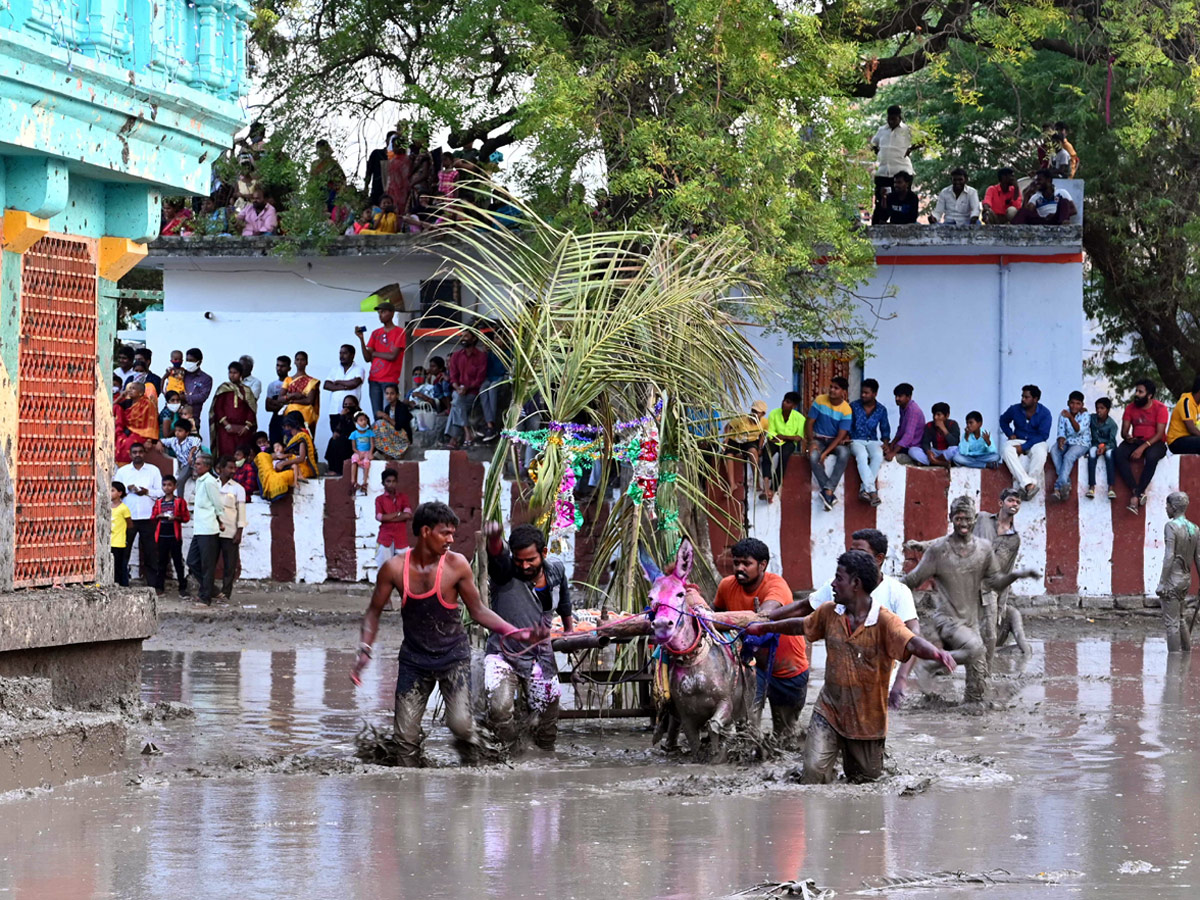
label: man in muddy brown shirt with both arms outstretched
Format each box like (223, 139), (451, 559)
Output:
(748, 550), (955, 785)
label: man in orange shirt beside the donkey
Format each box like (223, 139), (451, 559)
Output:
(713, 538), (809, 738)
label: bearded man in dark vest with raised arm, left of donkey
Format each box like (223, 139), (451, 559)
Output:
(484, 522), (574, 750)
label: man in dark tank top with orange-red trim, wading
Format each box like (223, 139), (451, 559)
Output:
(350, 503), (548, 767)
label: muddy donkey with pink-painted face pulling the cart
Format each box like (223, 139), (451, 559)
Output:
(641, 541), (755, 761)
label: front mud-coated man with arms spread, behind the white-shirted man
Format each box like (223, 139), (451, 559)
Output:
(902, 496), (1039, 703)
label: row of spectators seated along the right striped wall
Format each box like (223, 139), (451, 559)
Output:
(724, 376), (1200, 515)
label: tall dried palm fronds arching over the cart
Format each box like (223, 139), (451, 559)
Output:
(436, 190), (763, 608)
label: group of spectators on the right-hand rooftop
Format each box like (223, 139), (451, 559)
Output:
(871, 106), (1079, 226)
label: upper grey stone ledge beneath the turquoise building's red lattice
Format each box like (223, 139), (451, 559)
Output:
(0, 584), (158, 653)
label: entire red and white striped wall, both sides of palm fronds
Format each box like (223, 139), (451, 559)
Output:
(164, 451), (1200, 596)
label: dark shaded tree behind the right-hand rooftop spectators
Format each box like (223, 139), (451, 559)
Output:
(871, 42), (1200, 395)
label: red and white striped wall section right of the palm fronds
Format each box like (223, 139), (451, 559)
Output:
(710, 455), (1200, 596)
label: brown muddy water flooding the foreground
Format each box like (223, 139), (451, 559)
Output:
(0, 637), (1200, 900)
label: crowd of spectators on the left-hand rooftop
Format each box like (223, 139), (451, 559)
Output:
(160, 122), (504, 238)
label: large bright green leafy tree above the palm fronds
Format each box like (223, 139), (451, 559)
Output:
(250, 0), (872, 334)
